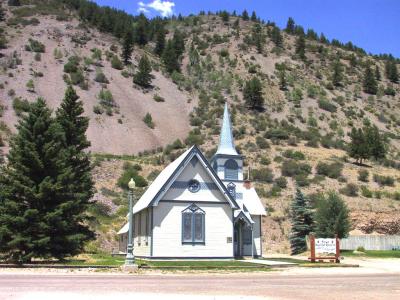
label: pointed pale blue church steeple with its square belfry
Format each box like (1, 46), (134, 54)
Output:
(211, 103), (243, 182)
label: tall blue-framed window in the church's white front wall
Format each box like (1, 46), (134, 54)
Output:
(182, 204), (205, 244)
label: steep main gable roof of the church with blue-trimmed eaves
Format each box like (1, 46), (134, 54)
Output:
(132, 146), (239, 214)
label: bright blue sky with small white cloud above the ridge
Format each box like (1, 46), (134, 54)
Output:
(95, 0), (400, 57)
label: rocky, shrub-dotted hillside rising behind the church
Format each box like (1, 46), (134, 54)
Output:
(0, 1), (400, 252)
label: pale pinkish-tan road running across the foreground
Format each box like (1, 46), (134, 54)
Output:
(0, 273), (400, 300)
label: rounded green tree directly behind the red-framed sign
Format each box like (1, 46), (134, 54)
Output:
(315, 192), (350, 239)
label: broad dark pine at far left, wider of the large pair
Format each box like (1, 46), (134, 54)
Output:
(0, 98), (63, 262)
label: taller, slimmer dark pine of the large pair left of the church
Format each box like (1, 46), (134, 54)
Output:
(50, 86), (94, 258)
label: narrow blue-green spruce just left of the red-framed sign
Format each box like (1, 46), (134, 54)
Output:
(289, 188), (314, 255)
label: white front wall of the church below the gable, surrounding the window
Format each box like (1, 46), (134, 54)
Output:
(152, 201), (233, 258)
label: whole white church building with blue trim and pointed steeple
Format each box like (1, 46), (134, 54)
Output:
(118, 104), (266, 259)
